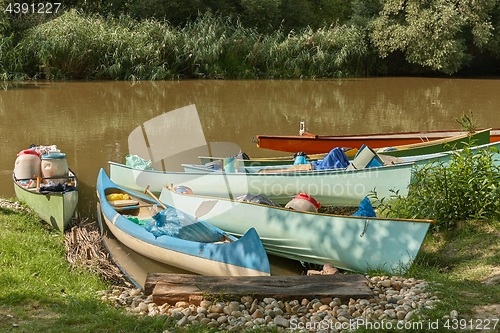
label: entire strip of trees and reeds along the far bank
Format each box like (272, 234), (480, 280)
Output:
(0, 0), (500, 80)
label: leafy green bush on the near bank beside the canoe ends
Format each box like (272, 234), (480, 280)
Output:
(381, 147), (500, 229)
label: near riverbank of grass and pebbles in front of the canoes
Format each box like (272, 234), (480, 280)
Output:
(0, 200), (500, 332)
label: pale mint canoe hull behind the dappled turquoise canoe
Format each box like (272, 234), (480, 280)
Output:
(109, 162), (413, 206)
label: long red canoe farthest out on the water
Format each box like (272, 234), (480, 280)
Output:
(254, 124), (500, 154)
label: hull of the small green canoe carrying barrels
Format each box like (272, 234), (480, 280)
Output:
(13, 171), (78, 232)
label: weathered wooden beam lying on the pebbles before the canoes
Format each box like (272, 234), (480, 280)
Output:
(144, 273), (373, 305)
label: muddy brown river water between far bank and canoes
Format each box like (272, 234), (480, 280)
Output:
(0, 78), (500, 282)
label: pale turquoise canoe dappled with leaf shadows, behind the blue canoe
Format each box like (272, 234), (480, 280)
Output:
(159, 188), (433, 274)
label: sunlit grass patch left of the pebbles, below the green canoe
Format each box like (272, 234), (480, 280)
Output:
(0, 208), (174, 333)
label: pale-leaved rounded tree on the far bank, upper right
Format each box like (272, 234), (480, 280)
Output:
(370, 0), (498, 74)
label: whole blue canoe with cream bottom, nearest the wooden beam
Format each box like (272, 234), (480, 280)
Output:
(96, 169), (270, 276)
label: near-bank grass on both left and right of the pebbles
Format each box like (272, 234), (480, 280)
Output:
(0, 201), (500, 333)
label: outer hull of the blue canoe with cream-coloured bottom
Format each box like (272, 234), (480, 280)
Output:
(96, 169), (270, 276)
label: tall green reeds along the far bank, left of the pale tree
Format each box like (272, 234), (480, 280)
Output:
(0, 10), (367, 80)
